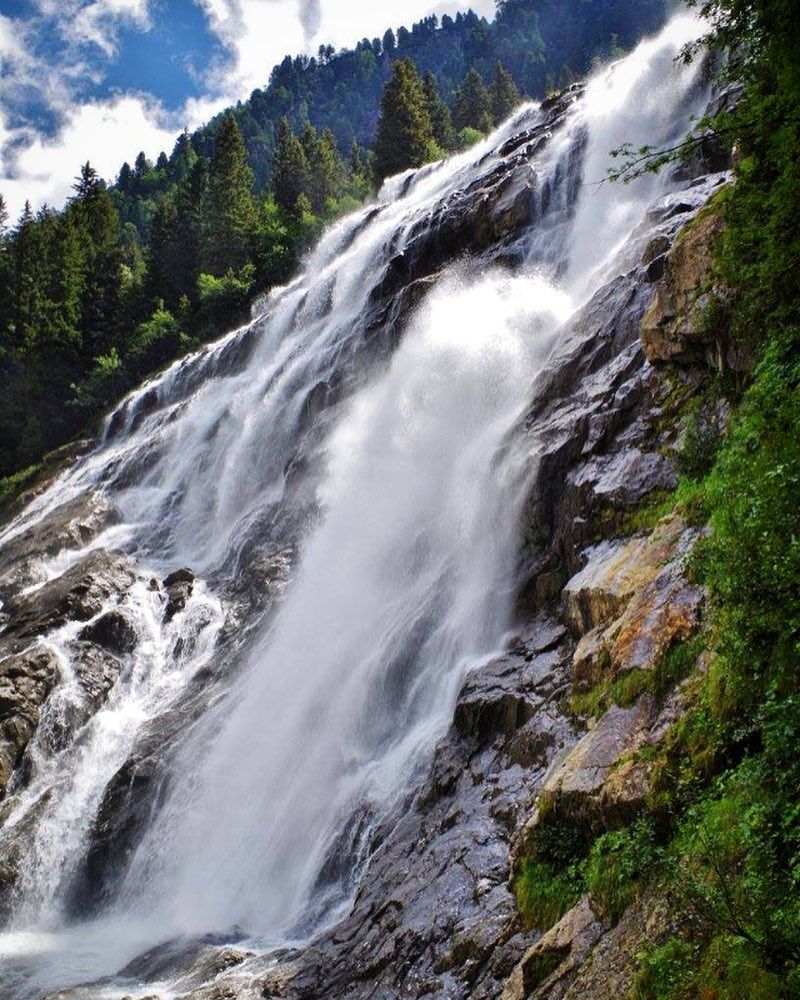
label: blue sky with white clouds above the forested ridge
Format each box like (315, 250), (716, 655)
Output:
(0, 0), (494, 220)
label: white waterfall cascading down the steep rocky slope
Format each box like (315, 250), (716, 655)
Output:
(0, 18), (704, 996)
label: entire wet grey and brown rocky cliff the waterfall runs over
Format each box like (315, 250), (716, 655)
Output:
(0, 37), (746, 1000)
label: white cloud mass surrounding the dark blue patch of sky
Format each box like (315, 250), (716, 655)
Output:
(0, 0), (494, 217)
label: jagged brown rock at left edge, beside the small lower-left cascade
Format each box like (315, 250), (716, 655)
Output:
(0, 645), (59, 799)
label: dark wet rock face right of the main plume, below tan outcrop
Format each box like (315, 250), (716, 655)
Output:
(520, 176), (723, 613)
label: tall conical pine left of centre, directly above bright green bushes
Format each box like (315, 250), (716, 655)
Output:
(201, 114), (257, 277)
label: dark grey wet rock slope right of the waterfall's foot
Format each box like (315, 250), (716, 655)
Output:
(236, 619), (574, 1000)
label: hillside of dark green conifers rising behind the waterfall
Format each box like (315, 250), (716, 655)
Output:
(0, 0), (665, 490)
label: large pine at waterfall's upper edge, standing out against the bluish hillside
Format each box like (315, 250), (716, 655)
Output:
(375, 59), (434, 180)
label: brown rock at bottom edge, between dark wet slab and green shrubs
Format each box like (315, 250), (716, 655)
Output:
(500, 896), (605, 1000)
